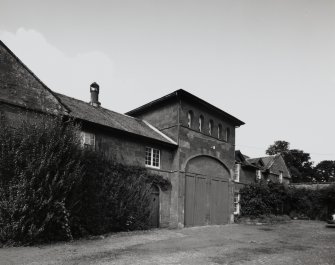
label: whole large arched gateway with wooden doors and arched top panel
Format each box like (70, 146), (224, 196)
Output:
(184, 156), (230, 226)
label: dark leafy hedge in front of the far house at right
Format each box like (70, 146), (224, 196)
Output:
(240, 182), (335, 220)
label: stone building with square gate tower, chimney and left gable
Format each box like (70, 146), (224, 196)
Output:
(0, 41), (244, 228)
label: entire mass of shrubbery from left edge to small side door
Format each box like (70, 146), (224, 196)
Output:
(0, 112), (171, 245)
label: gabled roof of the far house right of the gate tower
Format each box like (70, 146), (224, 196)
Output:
(246, 154), (291, 178)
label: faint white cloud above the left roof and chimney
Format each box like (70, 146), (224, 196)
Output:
(0, 28), (114, 104)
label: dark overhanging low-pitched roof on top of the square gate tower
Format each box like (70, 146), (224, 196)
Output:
(126, 89), (245, 126)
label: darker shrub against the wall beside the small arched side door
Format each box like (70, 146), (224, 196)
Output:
(73, 151), (170, 236)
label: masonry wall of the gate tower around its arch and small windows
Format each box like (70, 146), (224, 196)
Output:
(127, 98), (240, 227)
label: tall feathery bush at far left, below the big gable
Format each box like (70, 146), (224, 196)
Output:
(0, 116), (83, 244)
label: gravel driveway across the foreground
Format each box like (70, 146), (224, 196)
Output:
(0, 221), (335, 265)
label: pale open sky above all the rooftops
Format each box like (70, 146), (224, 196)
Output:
(0, 0), (335, 163)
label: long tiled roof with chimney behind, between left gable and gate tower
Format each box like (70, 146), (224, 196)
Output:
(56, 93), (177, 145)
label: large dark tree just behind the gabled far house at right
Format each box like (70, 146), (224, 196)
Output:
(266, 140), (313, 182)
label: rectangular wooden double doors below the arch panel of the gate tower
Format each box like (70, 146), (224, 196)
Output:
(184, 174), (229, 226)
